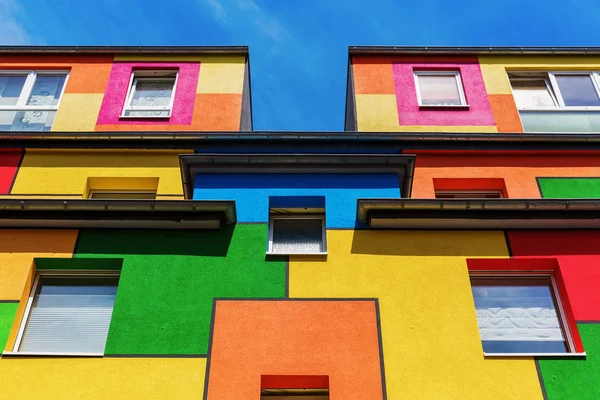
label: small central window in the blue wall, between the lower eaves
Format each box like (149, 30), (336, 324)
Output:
(268, 215), (327, 254)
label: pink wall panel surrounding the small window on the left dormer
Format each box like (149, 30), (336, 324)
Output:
(96, 62), (200, 125)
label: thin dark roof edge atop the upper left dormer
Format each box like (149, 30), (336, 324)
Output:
(0, 46), (248, 55)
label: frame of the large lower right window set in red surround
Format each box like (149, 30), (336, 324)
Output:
(469, 270), (585, 357)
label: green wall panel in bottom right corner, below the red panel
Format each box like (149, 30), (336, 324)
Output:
(539, 324), (600, 400)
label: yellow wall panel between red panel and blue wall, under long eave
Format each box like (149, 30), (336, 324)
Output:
(11, 150), (187, 196)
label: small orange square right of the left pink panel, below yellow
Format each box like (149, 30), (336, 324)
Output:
(192, 93), (242, 131)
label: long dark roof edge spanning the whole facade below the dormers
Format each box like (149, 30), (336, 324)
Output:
(5, 131), (600, 150)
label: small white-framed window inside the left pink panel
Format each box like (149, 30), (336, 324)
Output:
(121, 70), (177, 118)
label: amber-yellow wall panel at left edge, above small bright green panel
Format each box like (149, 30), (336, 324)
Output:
(0, 229), (77, 300)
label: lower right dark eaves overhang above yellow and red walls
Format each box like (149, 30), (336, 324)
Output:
(357, 199), (600, 230)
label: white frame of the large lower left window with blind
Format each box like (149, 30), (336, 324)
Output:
(2, 270), (121, 357)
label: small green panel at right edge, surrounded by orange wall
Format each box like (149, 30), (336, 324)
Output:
(538, 178), (600, 199)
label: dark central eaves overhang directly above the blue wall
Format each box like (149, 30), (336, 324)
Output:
(179, 154), (415, 199)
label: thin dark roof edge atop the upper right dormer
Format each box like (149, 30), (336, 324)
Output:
(348, 46), (600, 56)
